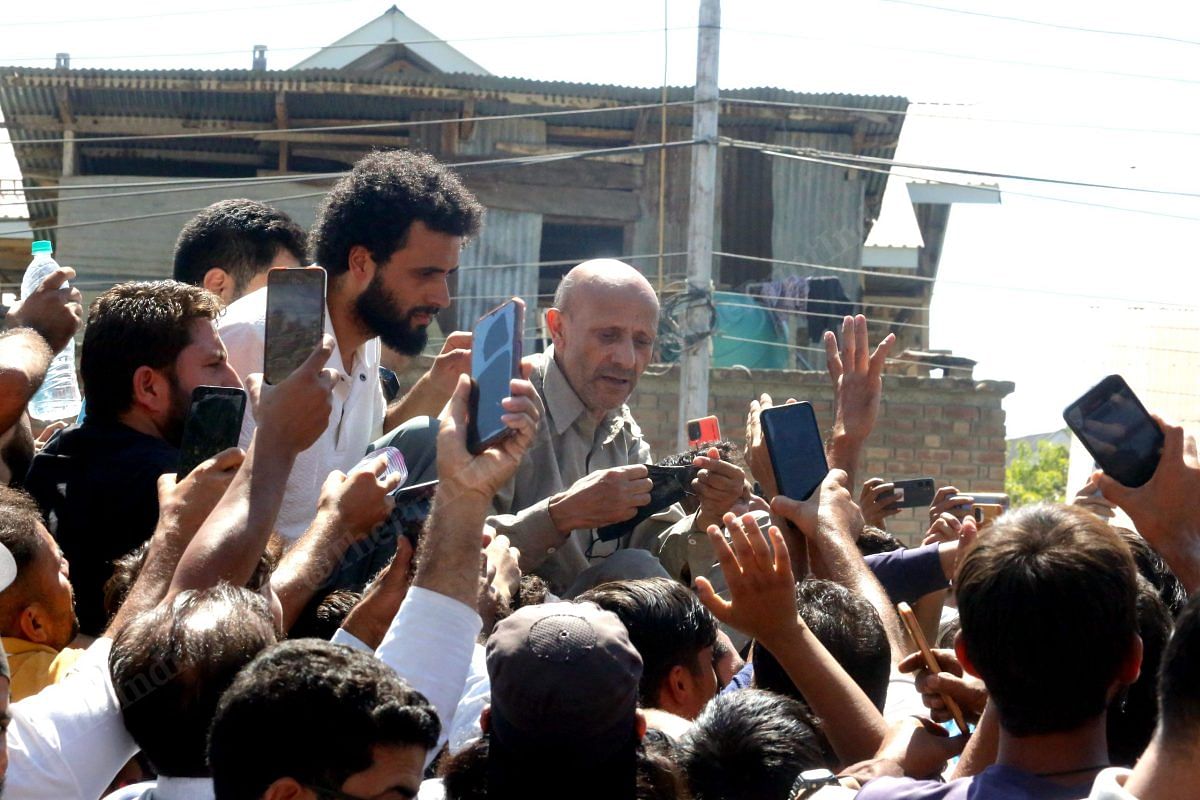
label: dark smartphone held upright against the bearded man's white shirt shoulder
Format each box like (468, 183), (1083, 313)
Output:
(263, 266), (325, 385)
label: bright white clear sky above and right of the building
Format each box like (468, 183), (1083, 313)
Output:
(0, 0), (1200, 435)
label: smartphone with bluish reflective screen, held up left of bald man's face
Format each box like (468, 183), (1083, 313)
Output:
(467, 297), (524, 455)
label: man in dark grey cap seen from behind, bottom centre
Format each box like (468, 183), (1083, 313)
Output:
(443, 603), (678, 800)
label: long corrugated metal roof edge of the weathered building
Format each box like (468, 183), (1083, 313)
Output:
(0, 67), (908, 239)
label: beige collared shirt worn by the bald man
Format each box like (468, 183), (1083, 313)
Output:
(487, 347), (661, 594)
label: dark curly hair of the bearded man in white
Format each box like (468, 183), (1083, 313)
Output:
(308, 150), (484, 278)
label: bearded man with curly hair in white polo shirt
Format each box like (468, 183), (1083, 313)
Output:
(221, 151), (484, 541)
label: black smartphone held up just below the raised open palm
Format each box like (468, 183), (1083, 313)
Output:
(760, 403), (829, 500)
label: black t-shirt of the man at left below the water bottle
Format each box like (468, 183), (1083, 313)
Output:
(25, 420), (179, 636)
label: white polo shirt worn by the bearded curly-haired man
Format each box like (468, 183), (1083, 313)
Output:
(220, 289), (388, 541)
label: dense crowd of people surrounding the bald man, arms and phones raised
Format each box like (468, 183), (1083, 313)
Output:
(0, 151), (1200, 800)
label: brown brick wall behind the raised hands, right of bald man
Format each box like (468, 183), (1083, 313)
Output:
(401, 359), (1013, 542)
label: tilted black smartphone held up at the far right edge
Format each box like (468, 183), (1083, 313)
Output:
(1062, 375), (1163, 486)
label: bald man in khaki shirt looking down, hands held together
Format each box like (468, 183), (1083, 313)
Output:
(488, 259), (744, 593)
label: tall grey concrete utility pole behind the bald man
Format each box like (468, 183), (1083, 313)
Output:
(676, 0), (721, 450)
